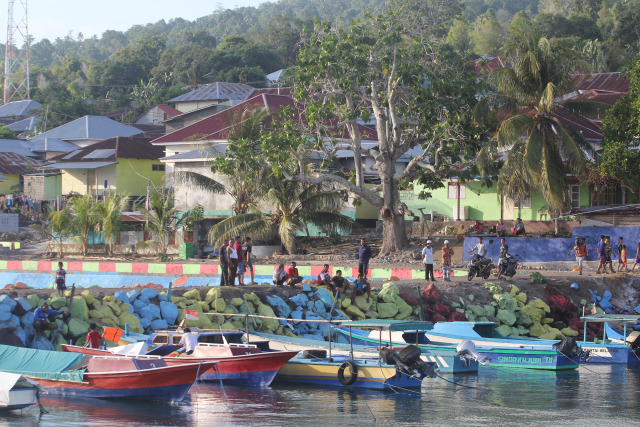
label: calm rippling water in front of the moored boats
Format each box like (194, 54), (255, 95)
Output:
(5, 366), (640, 427)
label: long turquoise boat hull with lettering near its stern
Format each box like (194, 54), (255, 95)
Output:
(337, 328), (579, 371)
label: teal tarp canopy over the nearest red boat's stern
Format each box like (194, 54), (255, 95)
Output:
(0, 345), (84, 381)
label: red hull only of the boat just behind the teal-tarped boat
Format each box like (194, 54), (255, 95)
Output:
(62, 345), (298, 387)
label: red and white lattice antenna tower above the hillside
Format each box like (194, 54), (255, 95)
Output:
(3, 0), (30, 104)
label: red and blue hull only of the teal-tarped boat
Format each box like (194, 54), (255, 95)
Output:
(26, 363), (215, 402)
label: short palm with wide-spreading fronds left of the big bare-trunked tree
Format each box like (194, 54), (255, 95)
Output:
(209, 175), (354, 254)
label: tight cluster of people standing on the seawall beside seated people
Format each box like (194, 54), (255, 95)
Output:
(218, 236), (257, 286)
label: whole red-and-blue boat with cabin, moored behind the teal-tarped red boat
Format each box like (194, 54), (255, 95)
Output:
(62, 343), (298, 387)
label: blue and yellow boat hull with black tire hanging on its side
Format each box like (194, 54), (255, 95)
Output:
(275, 357), (422, 390)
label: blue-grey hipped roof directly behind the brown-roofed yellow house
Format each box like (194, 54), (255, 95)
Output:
(32, 116), (142, 141)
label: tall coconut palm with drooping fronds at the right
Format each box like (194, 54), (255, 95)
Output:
(478, 33), (602, 217)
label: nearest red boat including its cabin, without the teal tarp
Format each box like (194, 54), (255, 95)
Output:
(24, 355), (216, 402)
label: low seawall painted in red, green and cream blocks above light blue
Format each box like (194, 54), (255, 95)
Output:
(0, 260), (466, 289)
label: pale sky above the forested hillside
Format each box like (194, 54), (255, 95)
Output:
(17, 0), (266, 43)
